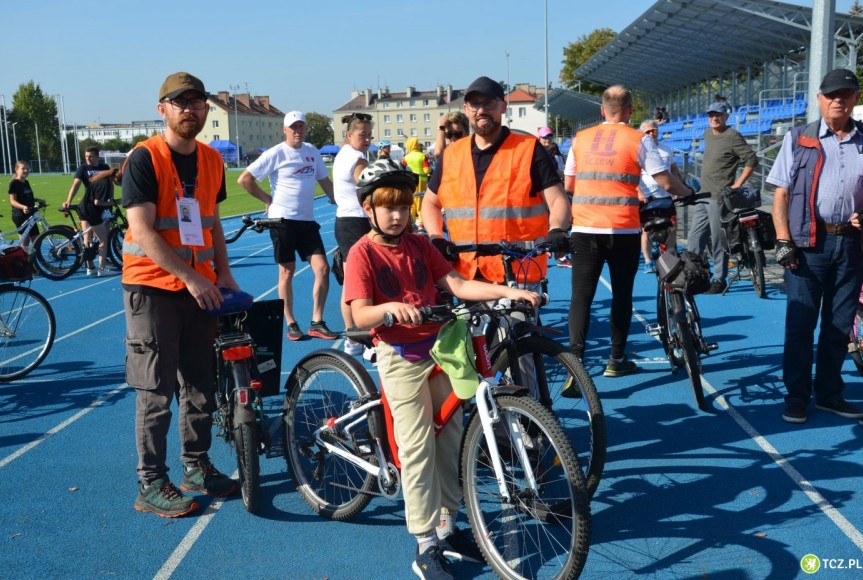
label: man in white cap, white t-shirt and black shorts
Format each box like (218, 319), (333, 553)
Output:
(243, 111), (338, 340)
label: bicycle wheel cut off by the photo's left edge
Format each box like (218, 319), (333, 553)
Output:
(0, 284), (56, 381)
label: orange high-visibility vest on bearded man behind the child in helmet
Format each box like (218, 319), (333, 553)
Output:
(437, 133), (548, 282)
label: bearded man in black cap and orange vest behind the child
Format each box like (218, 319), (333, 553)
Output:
(422, 77), (569, 283)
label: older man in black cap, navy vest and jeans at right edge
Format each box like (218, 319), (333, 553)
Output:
(767, 69), (863, 423)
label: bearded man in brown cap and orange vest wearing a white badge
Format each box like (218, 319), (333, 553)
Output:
(122, 72), (237, 518)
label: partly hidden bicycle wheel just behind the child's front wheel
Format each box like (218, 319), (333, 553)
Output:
(492, 336), (606, 496)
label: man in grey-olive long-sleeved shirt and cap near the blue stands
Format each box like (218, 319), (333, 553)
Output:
(686, 101), (758, 294)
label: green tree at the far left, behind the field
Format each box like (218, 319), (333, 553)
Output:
(9, 80), (60, 162)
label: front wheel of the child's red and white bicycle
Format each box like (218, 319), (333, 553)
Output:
(462, 396), (590, 578)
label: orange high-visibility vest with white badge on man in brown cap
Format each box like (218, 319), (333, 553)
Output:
(123, 135), (225, 291)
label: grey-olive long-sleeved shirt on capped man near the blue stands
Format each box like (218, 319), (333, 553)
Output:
(701, 127), (758, 199)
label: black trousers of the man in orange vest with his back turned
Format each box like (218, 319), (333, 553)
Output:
(569, 233), (641, 359)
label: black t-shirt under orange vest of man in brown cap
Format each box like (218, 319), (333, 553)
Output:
(122, 147), (228, 207)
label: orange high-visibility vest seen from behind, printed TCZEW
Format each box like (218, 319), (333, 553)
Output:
(572, 123), (644, 234)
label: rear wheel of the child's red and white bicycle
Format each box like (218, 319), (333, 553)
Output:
(284, 349), (376, 520)
